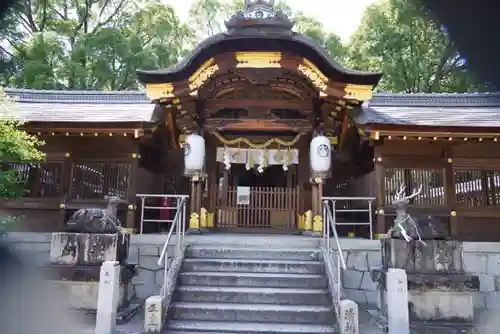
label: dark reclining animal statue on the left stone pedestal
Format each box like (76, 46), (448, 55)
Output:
(66, 198), (123, 233)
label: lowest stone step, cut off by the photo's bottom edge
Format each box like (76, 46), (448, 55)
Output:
(167, 320), (335, 334)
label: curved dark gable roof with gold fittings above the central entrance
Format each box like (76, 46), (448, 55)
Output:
(137, 0), (382, 100)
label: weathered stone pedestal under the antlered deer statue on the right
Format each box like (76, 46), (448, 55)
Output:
(373, 238), (479, 322)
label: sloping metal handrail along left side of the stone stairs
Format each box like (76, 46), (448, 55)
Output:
(158, 197), (187, 299)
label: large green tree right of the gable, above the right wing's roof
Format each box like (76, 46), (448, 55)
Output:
(349, 0), (485, 93)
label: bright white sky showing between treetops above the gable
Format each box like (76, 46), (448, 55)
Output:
(163, 0), (375, 42)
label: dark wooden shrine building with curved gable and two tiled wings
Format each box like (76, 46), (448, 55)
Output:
(0, 0), (500, 241)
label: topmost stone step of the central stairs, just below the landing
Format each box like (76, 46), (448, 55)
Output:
(185, 246), (322, 261)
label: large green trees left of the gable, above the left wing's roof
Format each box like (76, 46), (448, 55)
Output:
(0, 0), (190, 90)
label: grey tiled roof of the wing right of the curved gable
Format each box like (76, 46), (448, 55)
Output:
(353, 93), (500, 127)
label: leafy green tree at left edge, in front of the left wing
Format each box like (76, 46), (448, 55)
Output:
(0, 88), (45, 198)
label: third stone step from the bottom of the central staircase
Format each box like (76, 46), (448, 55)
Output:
(174, 285), (331, 305)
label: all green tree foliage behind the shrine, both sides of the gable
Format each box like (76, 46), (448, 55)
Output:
(0, 0), (486, 92)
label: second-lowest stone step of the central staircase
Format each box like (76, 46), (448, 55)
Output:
(169, 302), (335, 324)
